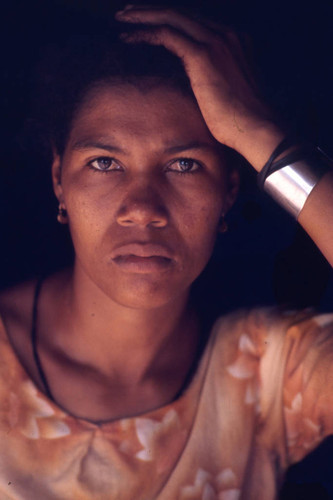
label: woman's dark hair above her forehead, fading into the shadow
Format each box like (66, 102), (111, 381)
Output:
(32, 29), (194, 158)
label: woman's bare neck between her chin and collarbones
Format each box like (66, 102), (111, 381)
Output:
(50, 267), (199, 384)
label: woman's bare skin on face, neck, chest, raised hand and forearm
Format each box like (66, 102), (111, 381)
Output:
(0, 6), (333, 422)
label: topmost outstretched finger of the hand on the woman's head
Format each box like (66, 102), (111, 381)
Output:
(116, 7), (214, 43)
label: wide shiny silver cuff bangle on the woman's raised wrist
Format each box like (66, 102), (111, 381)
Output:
(263, 149), (331, 220)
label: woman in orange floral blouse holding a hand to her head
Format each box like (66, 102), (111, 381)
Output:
(0, 7), (333, 500)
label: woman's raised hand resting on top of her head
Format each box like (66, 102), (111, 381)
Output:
(116, 6), (284, 171)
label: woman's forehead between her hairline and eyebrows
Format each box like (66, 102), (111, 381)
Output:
(69, 83), (218, 148)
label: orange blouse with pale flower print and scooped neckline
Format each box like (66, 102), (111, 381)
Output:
(0, 310), (333, 500)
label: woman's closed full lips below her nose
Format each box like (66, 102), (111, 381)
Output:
(111, 242), (174, 273)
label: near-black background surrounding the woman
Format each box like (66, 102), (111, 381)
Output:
(0, 0), (333, 499)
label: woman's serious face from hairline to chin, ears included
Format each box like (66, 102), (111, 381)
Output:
(53, 84), (235, 309)
